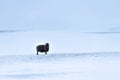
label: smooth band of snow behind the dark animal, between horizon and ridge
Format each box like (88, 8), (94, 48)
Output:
(0, 30), (120, 55)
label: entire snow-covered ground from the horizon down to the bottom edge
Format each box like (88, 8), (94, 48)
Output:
(0, 30), (120, 80)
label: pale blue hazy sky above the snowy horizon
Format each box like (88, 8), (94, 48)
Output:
(0, 0), (120, 31)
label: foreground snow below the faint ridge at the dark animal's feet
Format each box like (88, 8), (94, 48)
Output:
(0, 52), (120, 80)
